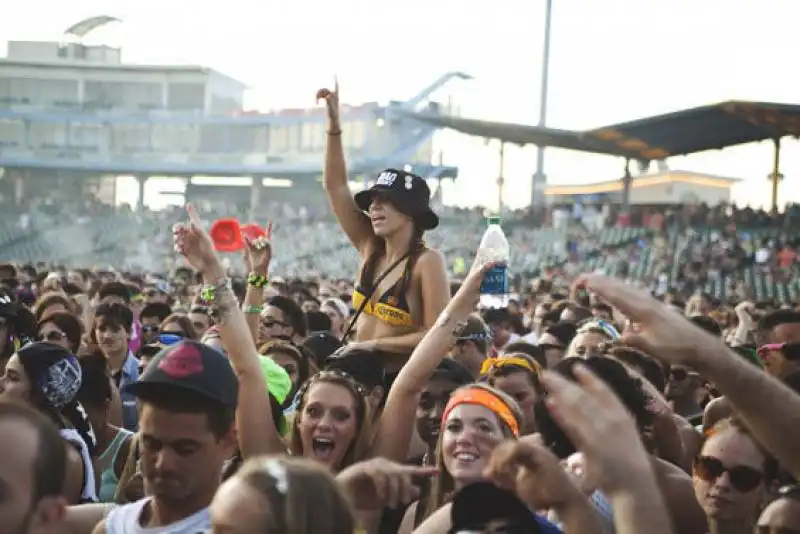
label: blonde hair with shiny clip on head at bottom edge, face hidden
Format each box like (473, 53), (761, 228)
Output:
(234, 456), (356, 534)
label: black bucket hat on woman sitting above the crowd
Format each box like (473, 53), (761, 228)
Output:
(355, 169), (439, 230)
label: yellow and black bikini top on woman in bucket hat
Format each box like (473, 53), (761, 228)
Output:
(352, 254), (414, 326)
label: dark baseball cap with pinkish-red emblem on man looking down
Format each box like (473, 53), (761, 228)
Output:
(123, 340), (239, 409)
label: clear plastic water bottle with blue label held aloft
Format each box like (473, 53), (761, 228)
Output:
(477, 217), (511, 308)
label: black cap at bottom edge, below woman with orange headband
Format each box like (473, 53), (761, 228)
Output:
(450, 482), (542, 534)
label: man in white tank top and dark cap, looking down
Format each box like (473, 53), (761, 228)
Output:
(94, 341), (238, 534)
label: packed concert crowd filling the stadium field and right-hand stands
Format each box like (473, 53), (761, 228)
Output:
(0, 84), (800, 534)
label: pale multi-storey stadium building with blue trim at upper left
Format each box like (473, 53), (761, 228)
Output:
(0, 34), (464, 210)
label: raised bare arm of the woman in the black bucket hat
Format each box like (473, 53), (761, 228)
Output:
(317, 81), (375, 256)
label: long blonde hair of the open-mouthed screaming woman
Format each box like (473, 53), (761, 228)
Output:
(289, 371), (373, 470)
